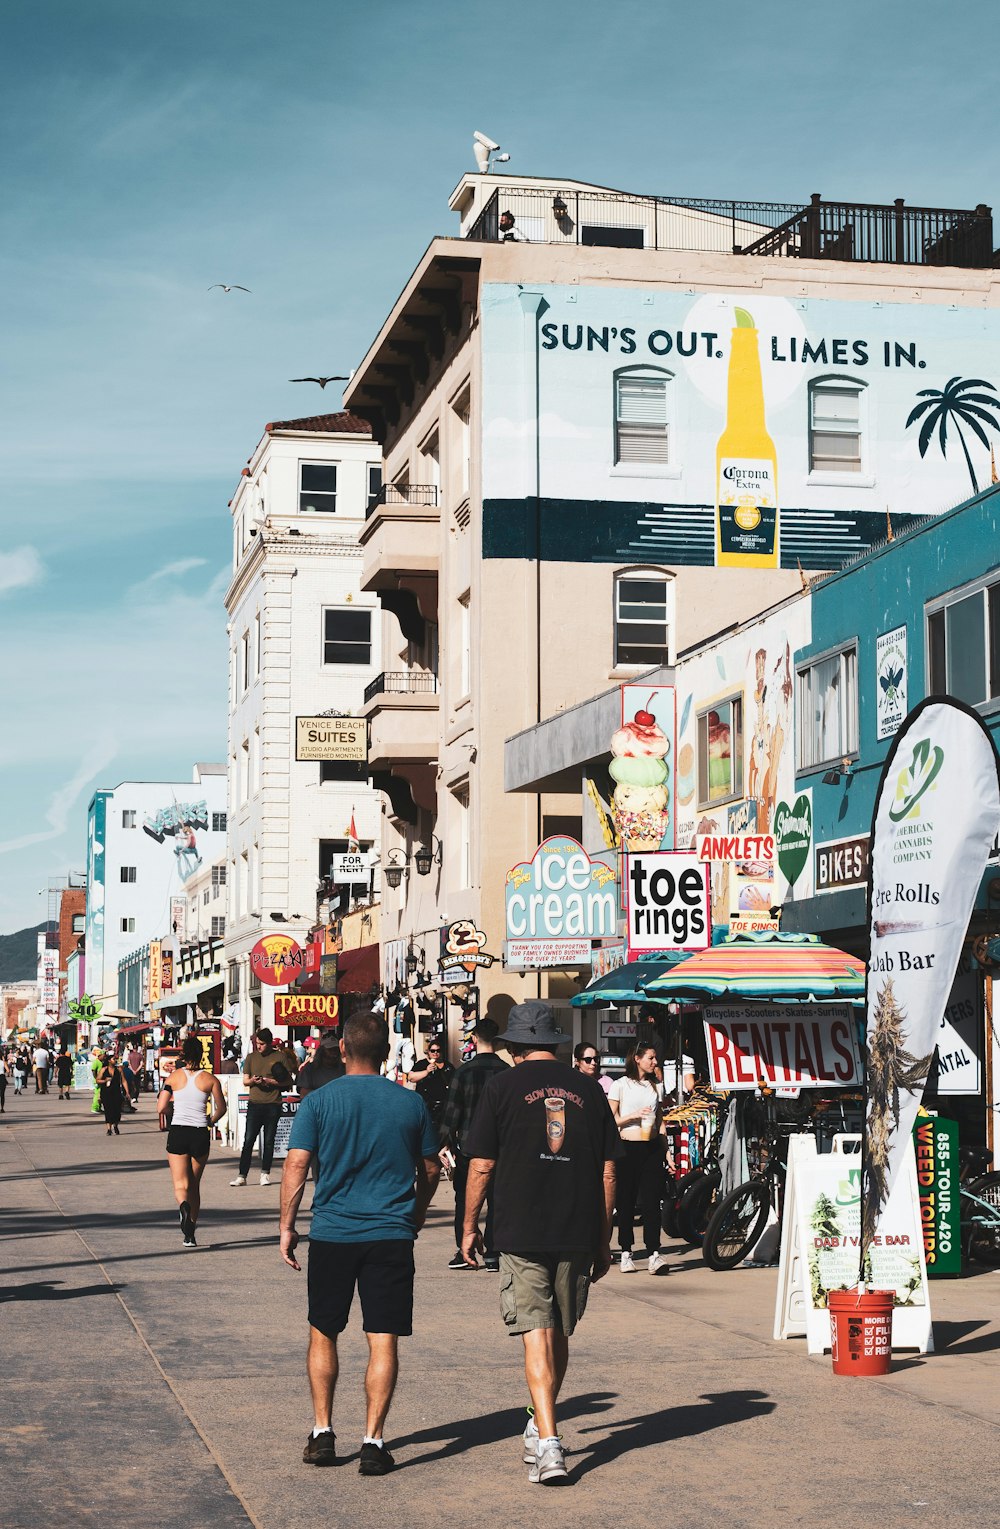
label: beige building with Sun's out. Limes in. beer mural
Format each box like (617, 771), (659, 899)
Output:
(344, 174), (1000, 1051)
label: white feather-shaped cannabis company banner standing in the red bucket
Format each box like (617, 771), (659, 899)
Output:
(861, 696), (1000, 1255)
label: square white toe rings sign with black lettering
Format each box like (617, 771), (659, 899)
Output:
(625, 850), (713, 956)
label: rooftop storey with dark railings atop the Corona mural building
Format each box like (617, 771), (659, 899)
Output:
(466, 185), (1000, 269)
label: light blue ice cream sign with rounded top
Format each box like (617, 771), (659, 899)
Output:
(505, 836), (618, 968)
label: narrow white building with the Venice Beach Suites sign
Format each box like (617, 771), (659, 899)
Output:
(225, 413), (385, 1034)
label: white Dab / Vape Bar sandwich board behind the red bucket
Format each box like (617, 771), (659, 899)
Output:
(774, 1136), (934, 1353)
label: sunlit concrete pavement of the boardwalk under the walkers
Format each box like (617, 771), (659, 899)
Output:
(0, 1090), (1000, 1529)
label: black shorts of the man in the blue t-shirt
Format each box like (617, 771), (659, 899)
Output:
(309, 1238), (413, 1338)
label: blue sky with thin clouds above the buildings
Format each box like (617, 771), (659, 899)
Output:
(0, 0), (1000, 933)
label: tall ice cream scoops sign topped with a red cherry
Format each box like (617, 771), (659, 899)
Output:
(609, 685), (674, 852)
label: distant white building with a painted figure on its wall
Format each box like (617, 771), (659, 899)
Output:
(86, 765), (226, 1008)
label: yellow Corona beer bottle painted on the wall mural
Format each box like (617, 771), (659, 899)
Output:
(716, 307), (778, 569)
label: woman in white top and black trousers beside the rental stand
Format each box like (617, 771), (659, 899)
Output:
(609, 1044), (668, 1275)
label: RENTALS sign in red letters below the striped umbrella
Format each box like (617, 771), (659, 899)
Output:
(705, 1003), (861, 1089)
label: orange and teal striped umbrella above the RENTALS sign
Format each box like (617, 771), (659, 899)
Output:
(645, 934), (865, 1003)
